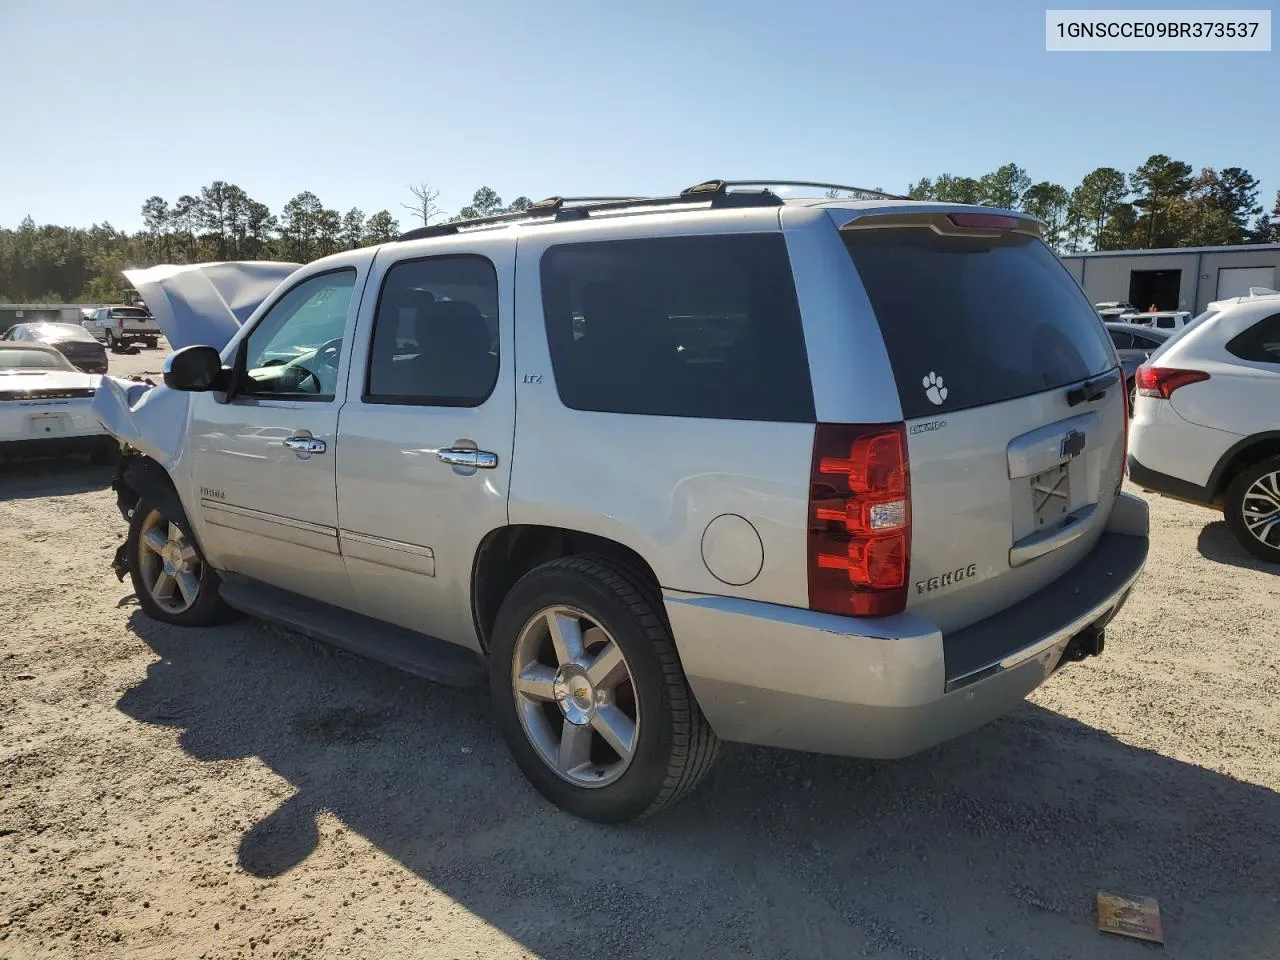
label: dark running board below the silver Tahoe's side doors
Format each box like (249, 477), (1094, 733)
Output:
(221, 575), (485, 686)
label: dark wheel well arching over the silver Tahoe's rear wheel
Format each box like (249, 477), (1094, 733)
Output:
(471, 524), (658, 650)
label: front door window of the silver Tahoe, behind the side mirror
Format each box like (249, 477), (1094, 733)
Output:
(242, 270), (356, 401)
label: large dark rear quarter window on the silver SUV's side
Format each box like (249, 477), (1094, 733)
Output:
(541, 233), (814, 422)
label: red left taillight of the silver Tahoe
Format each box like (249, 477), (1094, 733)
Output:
(809, 424), (911, 617)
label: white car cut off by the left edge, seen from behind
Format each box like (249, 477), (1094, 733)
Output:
(0, 342), (119, 462)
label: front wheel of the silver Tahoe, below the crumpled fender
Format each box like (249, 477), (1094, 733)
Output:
(125, 497), (232, 627)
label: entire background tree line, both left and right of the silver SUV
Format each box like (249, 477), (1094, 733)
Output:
(0, 160), (1280, 303)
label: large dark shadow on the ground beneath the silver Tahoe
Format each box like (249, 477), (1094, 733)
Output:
(118, 612), (1280, 959)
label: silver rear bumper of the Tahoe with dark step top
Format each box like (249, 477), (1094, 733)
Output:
(663, 494), (1147, 758)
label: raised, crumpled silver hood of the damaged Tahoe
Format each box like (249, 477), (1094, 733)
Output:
(123, 260), (301, 351)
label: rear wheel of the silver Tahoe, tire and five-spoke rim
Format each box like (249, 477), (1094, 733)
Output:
(489, 557), (719, 823)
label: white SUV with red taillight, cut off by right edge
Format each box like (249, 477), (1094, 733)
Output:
(1129, 294), (1280, 563)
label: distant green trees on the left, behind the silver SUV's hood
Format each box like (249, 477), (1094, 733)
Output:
(0, 180), (530, 303)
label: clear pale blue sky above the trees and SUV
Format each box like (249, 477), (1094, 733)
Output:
(0, 0), (1280, 229)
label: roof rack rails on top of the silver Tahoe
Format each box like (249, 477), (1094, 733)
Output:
(397, 180), (906, 241)
